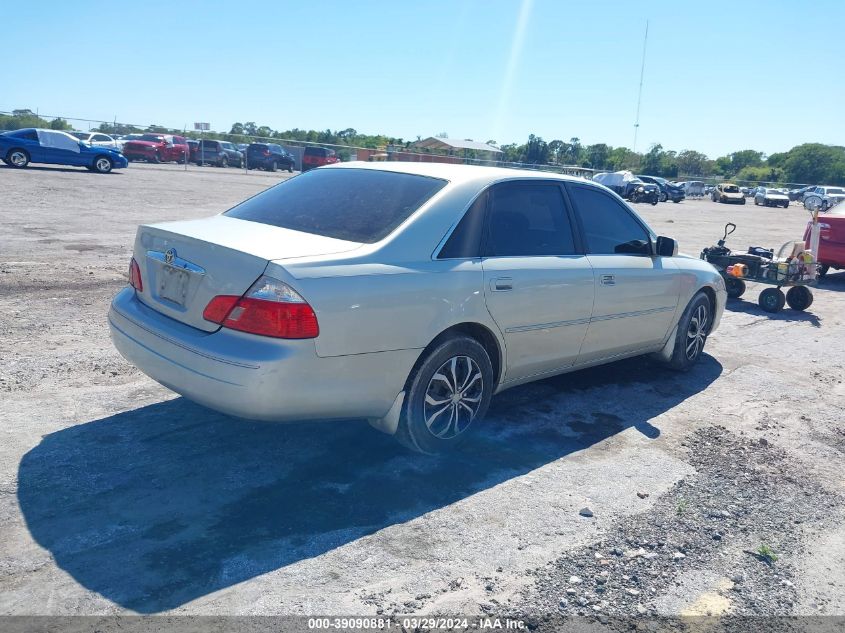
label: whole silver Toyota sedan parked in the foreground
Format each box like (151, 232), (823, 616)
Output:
(108, 162), (727, 453)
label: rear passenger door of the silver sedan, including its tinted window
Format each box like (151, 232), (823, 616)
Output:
(482, 180), (595, 382)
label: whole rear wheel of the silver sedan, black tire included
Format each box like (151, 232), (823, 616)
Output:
(396, 336), (494, 455)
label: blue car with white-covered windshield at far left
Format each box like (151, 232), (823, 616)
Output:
(0, 128), (129, 174)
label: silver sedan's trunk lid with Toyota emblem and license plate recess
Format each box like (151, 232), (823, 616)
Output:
(134, 215), (360, 332)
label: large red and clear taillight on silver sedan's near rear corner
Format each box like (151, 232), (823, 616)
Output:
(202, 275), (320, 338)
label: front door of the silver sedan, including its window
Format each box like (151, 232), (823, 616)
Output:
(567, 184), (681, 364)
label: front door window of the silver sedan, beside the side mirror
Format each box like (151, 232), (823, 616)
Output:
(570, 186), (651, 255)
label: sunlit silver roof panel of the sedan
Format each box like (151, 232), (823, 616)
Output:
(320, 161), (594, 184)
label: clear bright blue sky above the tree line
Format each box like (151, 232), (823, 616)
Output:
(0, 0), (845, 157)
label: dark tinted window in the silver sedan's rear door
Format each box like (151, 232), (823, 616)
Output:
(484, 183), (575, 257)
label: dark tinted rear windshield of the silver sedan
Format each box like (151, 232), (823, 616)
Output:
(225, 169), (446, 244)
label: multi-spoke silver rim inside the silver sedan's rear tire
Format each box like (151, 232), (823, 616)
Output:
(423, 356), (484, 439)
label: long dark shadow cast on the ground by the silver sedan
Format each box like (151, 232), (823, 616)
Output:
(18, 356), (722, 613)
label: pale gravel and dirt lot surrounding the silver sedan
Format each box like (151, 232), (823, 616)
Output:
(0, 164), (845, 630)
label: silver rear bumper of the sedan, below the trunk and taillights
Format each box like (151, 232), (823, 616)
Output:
(108, 288), (419, 421)
